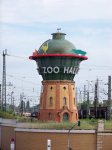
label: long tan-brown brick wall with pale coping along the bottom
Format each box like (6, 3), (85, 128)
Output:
(0, 125), (112, 150)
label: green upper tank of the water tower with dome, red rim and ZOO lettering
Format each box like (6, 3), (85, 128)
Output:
(30, 32), (87, 80)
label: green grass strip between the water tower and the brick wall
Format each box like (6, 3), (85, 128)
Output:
(16, 119), (97, 130)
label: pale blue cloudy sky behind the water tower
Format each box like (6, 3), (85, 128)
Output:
(0, 0), (112, 103)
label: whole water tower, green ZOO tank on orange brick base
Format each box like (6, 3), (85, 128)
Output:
(29, 31), (87, 122)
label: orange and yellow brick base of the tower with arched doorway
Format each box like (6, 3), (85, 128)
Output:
(39, 80), (78, 122)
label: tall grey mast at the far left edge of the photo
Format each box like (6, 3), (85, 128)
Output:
(2, 49), (7, 111)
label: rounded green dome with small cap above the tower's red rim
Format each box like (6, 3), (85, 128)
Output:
(38, 32), (76, 54)
